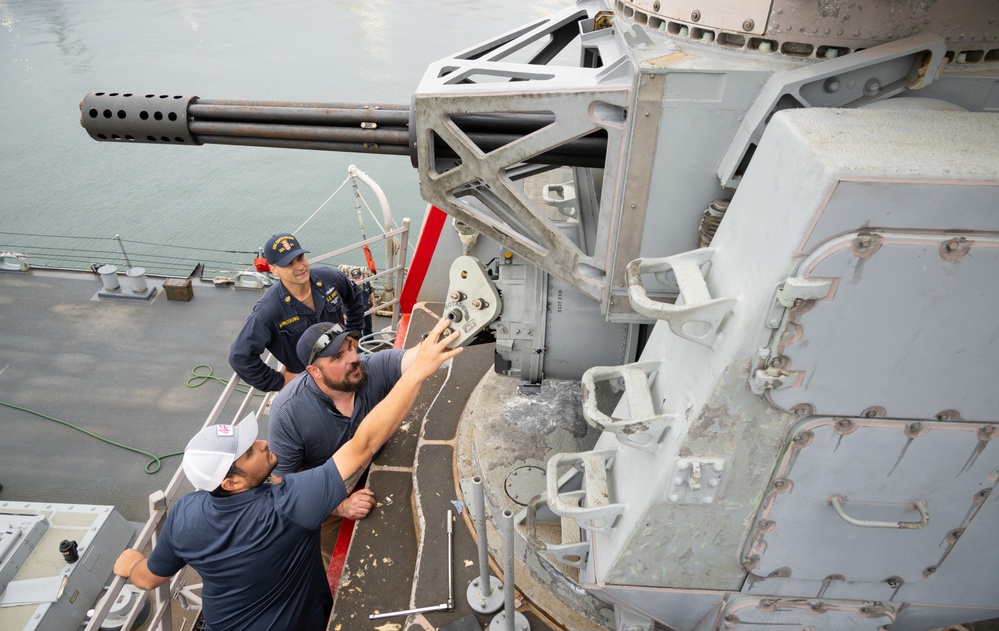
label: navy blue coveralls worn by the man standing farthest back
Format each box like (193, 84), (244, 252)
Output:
(229, 266), (365, 392)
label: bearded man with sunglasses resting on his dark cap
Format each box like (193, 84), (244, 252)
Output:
(268, 322), (416, 564)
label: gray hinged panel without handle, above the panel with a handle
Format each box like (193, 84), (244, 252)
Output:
(770, 235), (999, 420)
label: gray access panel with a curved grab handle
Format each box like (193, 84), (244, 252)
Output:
(750, 418), (997, 588)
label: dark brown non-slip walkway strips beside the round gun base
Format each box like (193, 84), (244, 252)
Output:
(329, 303), (572, 631)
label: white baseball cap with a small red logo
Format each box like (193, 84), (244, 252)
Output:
(184, 412), (257, 491)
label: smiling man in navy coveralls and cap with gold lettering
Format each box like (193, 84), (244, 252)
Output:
(229, 234), (366, 392)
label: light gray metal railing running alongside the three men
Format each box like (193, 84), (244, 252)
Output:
(85, 218), (410, 631)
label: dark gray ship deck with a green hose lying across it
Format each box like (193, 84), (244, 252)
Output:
(0, 269), (260, 522)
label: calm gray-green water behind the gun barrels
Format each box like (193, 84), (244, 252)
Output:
(0, 0), (568, 275)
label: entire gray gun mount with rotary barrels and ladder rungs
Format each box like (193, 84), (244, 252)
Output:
(82, 0), (999, 631)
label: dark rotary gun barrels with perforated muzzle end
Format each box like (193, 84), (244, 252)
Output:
(80, 92), (607, 167)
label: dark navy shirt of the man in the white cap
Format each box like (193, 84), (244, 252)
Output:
(148, 460), (347, 631)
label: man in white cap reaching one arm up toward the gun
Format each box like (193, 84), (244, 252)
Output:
(114, 319), (461, 631)
